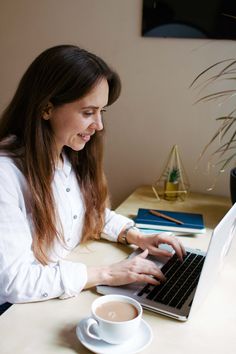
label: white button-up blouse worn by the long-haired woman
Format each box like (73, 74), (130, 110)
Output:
(0, 156), (132, 305)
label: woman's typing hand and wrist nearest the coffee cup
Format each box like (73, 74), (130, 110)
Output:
(85, 250), (165, 289)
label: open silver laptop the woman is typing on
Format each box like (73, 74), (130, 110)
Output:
(97, 203), (236, 321)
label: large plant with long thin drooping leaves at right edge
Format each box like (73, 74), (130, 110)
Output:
(191, 59), (236, 203)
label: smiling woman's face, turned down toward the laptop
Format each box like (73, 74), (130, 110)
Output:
(49, 79), (109, 158)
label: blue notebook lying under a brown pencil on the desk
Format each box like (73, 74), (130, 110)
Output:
(134, 208), (206, 233)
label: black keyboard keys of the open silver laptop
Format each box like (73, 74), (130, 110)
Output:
(138, 252), (205, 309)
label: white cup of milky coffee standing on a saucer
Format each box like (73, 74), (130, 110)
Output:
(84, 295), (142, 344)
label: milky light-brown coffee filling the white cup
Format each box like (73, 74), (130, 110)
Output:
(95, 301), (138, 322)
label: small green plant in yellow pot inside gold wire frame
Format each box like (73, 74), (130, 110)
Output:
(164, 166), (180, 200)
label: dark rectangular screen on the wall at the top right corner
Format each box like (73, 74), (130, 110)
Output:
(142, 0), (236, 39)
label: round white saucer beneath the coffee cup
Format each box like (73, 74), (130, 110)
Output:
(76, 319), (153, 354)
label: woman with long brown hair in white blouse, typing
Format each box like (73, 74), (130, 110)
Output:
(0, 45), (185, 304)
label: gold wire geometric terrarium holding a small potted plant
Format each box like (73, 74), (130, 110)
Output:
(152, 145), (190, 201)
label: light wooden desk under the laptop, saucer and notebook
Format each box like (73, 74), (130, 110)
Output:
(0, 186), (236, 354)
